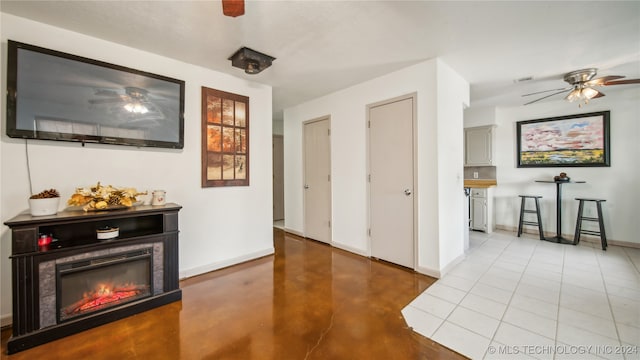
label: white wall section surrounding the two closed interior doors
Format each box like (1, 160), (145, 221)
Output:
(284, 59), (469, 276)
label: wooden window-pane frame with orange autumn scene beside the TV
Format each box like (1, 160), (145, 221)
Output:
(202, 86), (249, 187)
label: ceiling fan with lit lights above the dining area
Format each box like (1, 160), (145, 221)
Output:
(522, 68), (640, 107)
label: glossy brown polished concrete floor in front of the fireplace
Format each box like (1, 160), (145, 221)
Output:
(2, 229), (464, 360)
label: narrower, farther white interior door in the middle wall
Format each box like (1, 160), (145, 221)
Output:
(304, 118), (331, 243)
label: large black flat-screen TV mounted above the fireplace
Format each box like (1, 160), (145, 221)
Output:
(7, 40), (185, 149)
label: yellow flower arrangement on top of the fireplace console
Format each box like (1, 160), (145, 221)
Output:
(67, 182), (147, 211)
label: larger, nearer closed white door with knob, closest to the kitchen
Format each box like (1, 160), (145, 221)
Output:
(369, 98), (415, 269)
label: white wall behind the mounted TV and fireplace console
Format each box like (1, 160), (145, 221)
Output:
(0, 14), (273, 319)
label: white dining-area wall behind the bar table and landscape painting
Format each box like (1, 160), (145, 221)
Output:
(488, 86), (640, 245)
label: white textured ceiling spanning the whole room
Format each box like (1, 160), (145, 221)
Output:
(0, 0), (640, 118)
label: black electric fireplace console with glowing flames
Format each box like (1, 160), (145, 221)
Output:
(5, 204), (182, 354)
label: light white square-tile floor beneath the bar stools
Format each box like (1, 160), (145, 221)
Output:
(402, 231), (640, 360)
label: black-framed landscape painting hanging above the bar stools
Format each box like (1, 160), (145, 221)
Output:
(516, 111), (611, 168)
